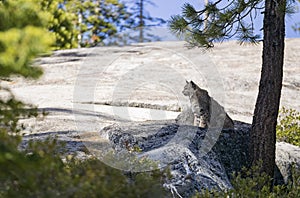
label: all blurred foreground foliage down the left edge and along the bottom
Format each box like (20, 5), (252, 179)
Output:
(0, 0), (164, 198)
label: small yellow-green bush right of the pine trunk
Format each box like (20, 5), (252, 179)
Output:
(276, 107), (300, 146)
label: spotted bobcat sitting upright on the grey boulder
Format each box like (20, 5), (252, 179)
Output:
(182, 81), (234, 128)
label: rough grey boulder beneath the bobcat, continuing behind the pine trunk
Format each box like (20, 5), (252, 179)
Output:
(101, 121), (300, 197)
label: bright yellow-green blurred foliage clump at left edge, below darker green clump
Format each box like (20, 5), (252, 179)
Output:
(0, 26), (51, 78)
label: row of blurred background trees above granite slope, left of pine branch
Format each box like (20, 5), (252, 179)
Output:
(30, 0), (165, 49)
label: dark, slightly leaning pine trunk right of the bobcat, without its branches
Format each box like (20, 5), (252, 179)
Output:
(251, 0), (286, 178)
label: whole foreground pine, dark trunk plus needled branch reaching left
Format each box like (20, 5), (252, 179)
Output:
(169, 0), (289, 184)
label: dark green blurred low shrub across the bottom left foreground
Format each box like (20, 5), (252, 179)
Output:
(0, 132), (165, 198)
